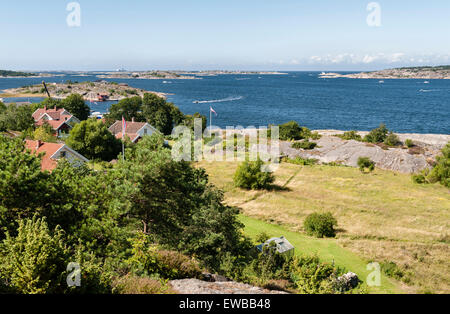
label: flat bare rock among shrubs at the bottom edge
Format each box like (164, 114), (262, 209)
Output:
(169, 279), (287, 294)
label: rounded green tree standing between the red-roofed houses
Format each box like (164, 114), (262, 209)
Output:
(66, 119), (122, 161)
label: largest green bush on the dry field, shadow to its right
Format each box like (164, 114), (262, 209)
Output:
(234, 159), (275, 190)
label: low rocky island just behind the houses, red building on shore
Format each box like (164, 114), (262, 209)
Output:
(0, 81), (166, 101)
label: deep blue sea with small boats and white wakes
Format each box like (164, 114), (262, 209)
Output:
(0, 72), (450, 134)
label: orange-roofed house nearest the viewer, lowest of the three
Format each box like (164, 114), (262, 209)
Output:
(25, 140), (89, 171)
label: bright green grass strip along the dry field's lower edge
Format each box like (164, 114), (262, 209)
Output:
(240, 215), (400, 293)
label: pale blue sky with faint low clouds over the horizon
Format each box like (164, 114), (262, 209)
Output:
(0, 0), (450, 71)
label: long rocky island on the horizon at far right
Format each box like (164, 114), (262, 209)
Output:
(319, 65), (450, 80)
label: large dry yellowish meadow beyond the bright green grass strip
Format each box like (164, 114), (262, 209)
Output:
(199, 161), (450, 293)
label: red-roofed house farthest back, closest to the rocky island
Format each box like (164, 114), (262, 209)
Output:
(33, 106), (80, 136)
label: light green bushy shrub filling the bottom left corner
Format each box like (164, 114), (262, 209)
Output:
(0, 218), (69, 294)
